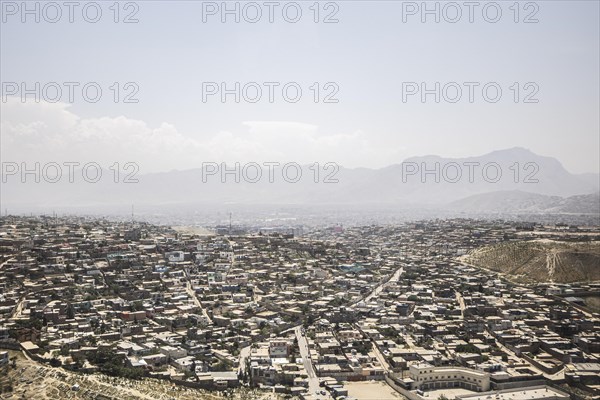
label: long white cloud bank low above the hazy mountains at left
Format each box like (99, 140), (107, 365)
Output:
(0, 99), (404, 173)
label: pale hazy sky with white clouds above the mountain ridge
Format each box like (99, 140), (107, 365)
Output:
(0, 1), (600, 173)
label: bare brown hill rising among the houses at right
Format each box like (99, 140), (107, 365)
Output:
(464, 240), (600, 283)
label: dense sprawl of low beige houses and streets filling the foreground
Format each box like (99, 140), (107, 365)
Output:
(0, 216), (600, 400)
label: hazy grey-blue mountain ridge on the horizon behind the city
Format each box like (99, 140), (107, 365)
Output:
(1, 148), (600, 213)
